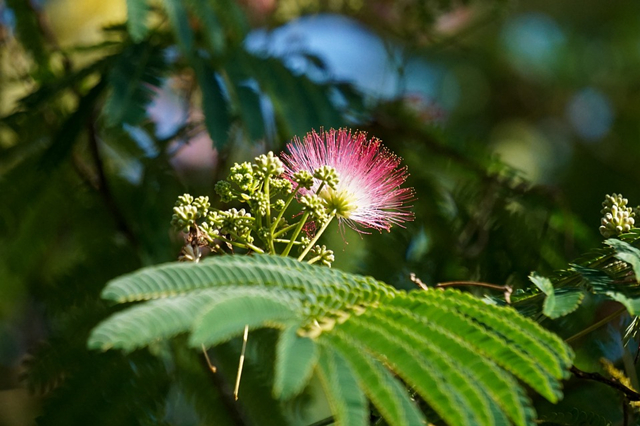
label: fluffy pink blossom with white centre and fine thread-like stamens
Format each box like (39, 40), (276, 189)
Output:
(282, 129), (414, 232)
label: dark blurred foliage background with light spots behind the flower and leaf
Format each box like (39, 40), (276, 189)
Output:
(0, 0), (640, 426)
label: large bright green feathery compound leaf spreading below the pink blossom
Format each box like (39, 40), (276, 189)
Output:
(89, 255), (573, 426)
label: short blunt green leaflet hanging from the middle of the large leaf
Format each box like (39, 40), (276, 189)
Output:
(273, 325), (318, 399)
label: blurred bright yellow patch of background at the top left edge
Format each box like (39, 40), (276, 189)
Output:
(45, 0), (127, 48)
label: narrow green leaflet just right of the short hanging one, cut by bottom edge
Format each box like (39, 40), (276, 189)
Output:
(319, 347), (369, 426)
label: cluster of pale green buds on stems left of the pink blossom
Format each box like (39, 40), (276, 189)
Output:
(171, 152), (339, 266)
